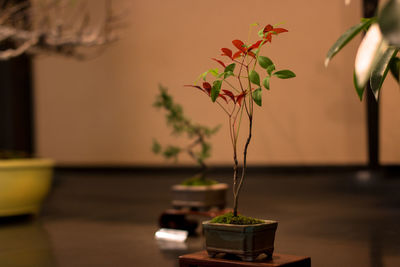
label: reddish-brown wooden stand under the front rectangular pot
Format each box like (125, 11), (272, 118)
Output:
(179, 250), (311, 267)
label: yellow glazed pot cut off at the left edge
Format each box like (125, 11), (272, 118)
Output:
(0, 159), (54, 216)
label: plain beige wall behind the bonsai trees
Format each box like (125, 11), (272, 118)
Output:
(35, 0), (400, 165)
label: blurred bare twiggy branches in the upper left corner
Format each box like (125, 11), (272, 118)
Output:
(0, 0), (122, 60)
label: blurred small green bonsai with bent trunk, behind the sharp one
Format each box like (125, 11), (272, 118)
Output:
(153, 85), (220, 185)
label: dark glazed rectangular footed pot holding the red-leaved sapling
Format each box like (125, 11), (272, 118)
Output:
(203, 220), (278, 261)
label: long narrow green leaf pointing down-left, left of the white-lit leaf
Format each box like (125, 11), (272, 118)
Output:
(325, 18), (376, 67)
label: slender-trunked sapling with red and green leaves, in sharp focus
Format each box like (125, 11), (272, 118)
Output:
(187, 24), (296, 220)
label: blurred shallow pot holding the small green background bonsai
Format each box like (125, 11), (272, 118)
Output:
(172, 183), (228, 210)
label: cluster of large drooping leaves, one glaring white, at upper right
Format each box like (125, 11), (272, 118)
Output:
(325, 0), (400, 101)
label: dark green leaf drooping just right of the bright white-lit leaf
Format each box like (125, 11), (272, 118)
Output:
(369, 47), (397, 101)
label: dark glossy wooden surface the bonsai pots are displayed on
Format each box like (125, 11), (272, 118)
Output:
(0, 170), (400, 267)
